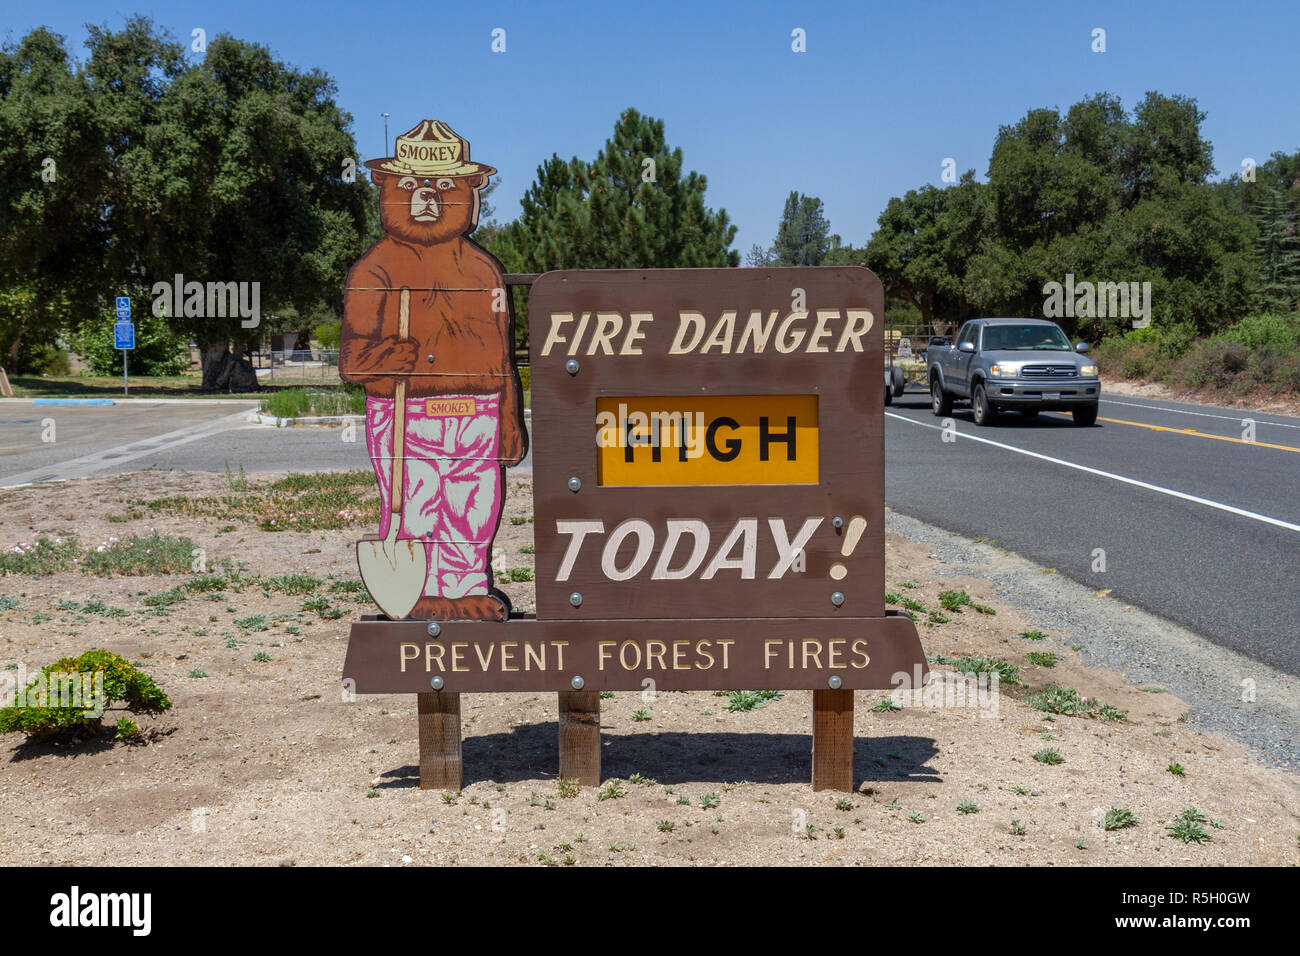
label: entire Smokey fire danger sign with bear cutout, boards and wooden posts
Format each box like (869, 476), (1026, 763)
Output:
(341, 121), (926, 790)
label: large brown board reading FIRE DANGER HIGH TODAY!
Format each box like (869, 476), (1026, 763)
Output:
(529, 268), (884, 620)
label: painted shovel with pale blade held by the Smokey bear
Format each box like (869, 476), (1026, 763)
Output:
(356, 289), (429, 620)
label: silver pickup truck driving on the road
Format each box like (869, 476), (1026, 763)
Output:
(927, 319), (1101, 425)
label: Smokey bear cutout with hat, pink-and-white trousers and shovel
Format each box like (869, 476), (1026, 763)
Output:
(339, 120), (528, 620)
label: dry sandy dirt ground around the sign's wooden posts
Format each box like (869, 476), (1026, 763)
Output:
(0, 472), (1300, 866)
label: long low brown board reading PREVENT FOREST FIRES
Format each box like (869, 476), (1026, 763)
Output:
(343, 611), (923, 693)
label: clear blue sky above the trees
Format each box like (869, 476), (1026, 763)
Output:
(0, 0), (1300, 254)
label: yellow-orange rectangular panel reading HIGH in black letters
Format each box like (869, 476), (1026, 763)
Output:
(595, 395), (819, 485)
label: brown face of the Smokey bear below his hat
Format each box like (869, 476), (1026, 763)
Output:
(371, 173), (488, 246)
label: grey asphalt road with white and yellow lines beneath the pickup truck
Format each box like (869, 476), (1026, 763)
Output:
(885, 392), (1300, 674)
